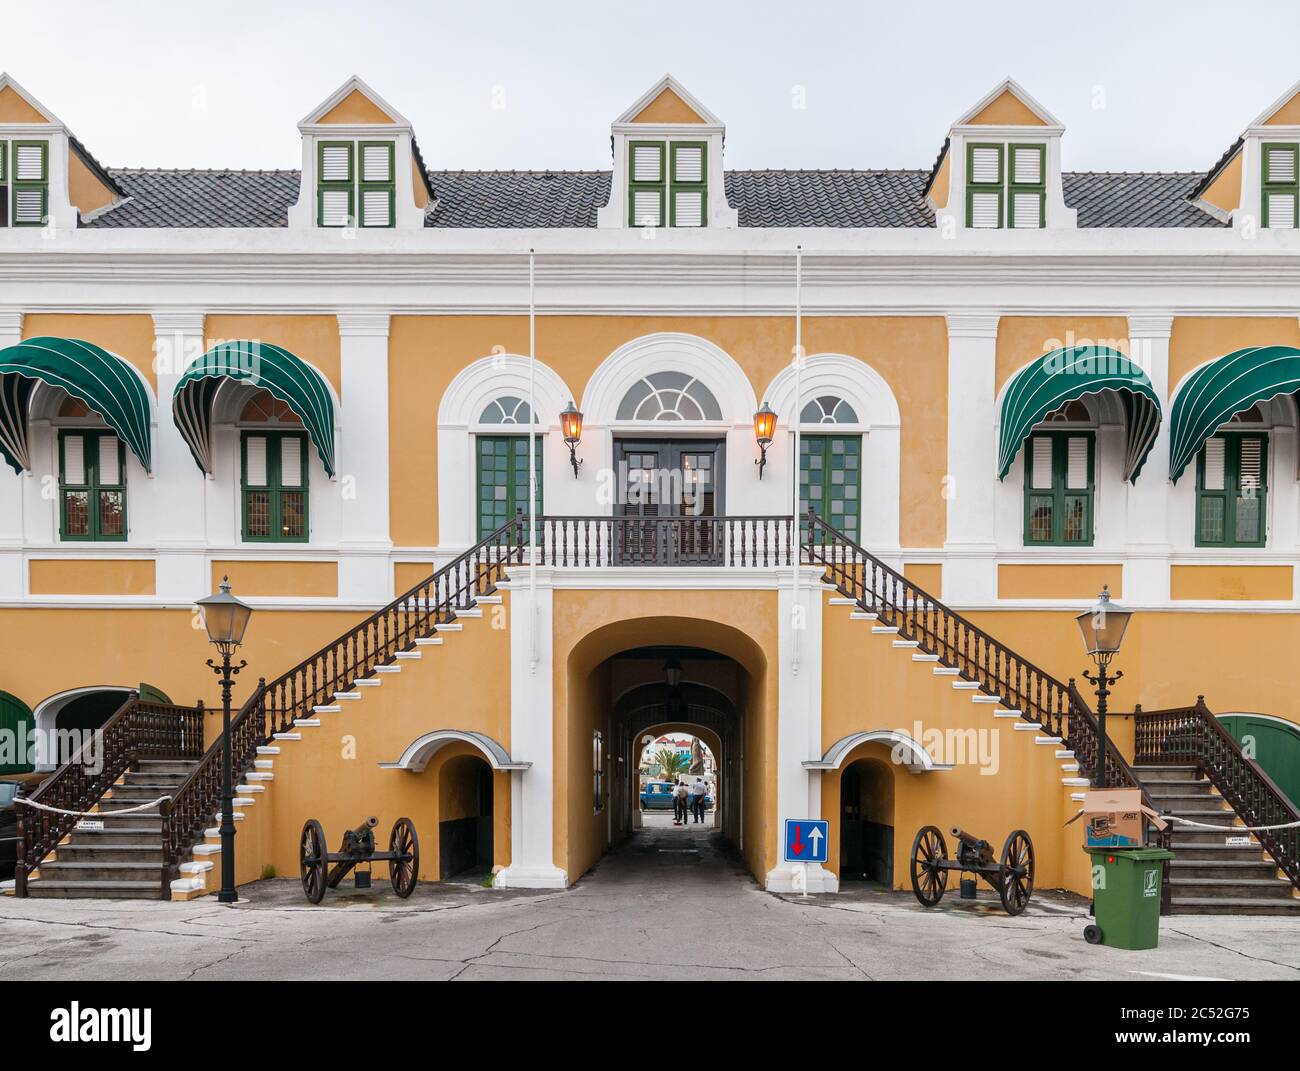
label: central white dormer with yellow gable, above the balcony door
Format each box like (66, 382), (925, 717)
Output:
(597, 74), (740, 229)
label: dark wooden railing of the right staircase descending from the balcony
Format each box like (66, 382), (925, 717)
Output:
(800, 511), (1170, 910)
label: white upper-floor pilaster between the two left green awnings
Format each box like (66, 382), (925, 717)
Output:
(151, 309), (212, 600)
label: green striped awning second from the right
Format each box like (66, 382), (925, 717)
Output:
(997, 346), (1161, 482)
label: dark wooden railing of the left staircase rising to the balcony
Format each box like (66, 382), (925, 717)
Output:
(163, 515), (527, 897)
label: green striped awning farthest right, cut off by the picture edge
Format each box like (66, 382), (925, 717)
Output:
(1169, 346), (1300, 484)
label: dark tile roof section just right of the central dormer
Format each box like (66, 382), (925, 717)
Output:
(725, 172), (935, 227)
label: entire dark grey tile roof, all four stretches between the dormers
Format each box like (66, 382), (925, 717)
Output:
(86, 169), (1223, 229)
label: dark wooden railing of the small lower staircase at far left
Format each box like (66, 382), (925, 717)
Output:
(14, 691), (203, 897)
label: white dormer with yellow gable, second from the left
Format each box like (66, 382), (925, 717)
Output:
(289, 75), (433, 234)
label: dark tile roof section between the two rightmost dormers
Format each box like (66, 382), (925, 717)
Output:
(1061, 172), (1227, 227)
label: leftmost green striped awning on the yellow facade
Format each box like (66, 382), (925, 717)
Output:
(0, 338), (153, 472)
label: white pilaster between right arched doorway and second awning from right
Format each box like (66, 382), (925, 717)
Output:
(935, 312), (998, 604)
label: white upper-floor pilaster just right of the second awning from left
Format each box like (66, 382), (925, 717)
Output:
(337, 312), (393, 602)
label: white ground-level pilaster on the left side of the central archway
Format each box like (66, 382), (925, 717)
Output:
(495, 568), (568, 889)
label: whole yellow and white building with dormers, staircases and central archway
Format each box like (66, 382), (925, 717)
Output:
(0, 75), (1300, 899)
